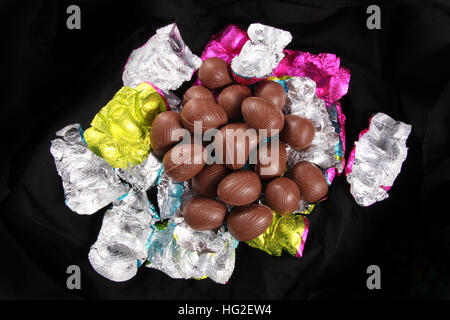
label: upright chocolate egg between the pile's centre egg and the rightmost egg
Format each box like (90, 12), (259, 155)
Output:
(255, 141), (287, 179)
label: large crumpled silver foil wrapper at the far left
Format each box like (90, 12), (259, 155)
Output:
(50, 124), (130, 214)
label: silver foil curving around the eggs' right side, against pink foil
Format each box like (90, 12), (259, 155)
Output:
(285, 77), (343, 171)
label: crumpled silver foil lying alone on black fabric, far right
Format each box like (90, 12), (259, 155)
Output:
(345, 113), (411, 207)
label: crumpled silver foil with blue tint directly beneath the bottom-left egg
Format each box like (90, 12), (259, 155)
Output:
(146, 222), (238, 284)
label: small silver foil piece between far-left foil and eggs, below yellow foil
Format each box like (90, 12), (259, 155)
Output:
(116, 153), (162, 191)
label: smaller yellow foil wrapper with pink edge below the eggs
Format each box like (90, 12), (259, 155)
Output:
(246, 211), (309, 257)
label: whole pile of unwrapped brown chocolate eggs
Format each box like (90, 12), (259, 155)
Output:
(150, 58), (328, 241)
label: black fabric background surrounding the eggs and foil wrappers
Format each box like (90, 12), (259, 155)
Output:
(0, 0), (450, 299)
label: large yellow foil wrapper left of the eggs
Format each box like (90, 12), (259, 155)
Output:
(84, 82), (167, 169)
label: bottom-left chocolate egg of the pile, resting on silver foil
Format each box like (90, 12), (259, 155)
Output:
(183, 197), (227, 231)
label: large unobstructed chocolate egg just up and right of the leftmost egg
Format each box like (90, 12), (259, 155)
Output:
(181, 99), (228, 133)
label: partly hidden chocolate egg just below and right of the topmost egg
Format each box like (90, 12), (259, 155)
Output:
(217, 84), (252, 119)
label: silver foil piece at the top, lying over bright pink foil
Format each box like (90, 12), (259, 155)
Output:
(231, 23), (292, 78)
